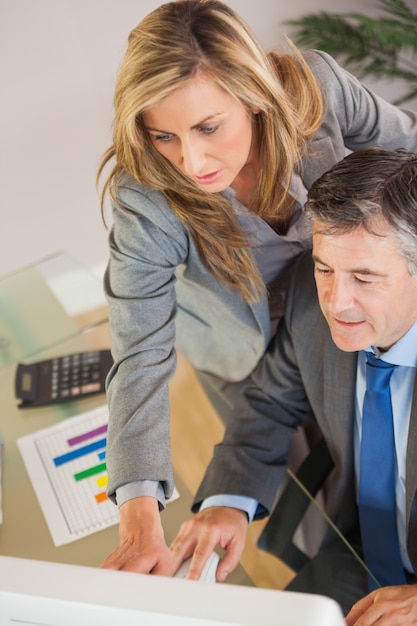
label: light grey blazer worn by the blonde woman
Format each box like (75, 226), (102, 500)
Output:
(105, 51), (417, 498)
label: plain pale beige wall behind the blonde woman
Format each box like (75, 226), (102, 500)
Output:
(0, 0), (412, 275)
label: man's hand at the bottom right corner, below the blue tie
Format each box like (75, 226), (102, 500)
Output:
(346, 585), (417, 626)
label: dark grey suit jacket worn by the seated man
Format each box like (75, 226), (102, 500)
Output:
(193, 253), (417, 571)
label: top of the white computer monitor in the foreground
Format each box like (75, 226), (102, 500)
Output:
(0, 556), (344, 626)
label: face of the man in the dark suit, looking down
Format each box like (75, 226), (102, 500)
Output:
(313, 218), (417, 352)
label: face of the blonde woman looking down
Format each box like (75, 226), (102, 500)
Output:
(143, 73), (257, 192)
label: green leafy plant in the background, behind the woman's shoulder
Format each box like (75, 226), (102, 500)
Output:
(287, 0), (417, 105)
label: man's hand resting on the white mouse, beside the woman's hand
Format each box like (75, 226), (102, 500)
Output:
(171, 506), (248, 582)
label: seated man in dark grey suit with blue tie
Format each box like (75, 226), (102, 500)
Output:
(168, 148), (417, 625)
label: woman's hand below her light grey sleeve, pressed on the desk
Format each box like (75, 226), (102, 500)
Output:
(100, 496), (175, 576)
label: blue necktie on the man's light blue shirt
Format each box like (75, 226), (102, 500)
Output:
(359, 353), (406, 591)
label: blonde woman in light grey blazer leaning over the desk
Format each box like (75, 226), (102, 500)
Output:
(99, 0), (417, 574)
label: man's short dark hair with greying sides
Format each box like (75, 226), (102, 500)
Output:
(305, 148), (417, 275)
